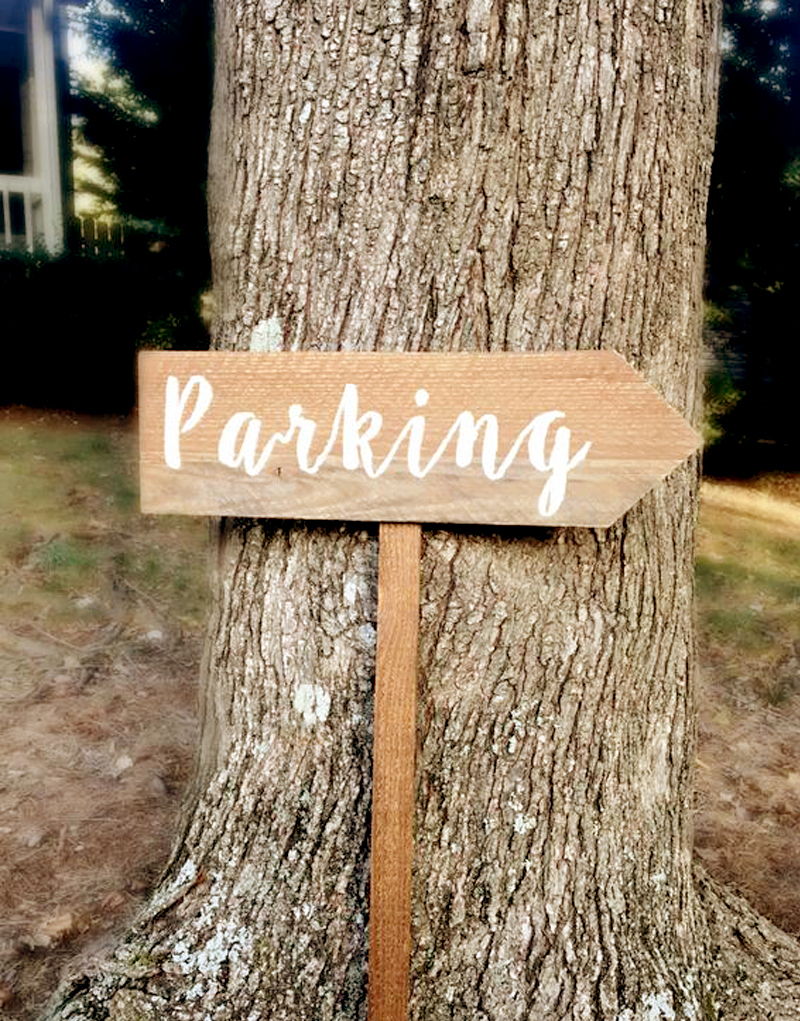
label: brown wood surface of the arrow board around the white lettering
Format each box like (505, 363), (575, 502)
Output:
(139, 351), (700, 527)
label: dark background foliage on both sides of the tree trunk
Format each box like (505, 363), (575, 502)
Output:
(0, 0), (800, 459)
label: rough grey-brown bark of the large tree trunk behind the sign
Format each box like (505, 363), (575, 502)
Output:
(42, 0), (800, 1021)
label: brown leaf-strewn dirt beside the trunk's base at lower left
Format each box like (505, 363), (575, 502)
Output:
(0, 629), (198, 1019)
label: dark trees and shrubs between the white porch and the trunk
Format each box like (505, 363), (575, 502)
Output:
(0, 0), (212, 415)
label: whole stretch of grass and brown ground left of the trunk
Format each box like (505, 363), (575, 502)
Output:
(0, 409), (206, 1021)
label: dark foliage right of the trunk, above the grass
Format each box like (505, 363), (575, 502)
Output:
(705, 0), (800, 476)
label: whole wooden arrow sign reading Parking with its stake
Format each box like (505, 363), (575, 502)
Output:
(139, 351), (700, 1021)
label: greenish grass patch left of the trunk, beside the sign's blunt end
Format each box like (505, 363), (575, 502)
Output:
(0, 415), (207, 631)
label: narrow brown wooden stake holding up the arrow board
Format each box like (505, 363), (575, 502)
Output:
(369, 524), (421, 1021)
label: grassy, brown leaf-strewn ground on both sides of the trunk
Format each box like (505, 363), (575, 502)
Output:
(0, 410), (800, 1021)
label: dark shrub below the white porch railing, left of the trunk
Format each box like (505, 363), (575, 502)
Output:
(0, 251), (208, 415)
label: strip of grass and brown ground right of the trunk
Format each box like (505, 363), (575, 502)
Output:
(695, 475), (800, 936)
